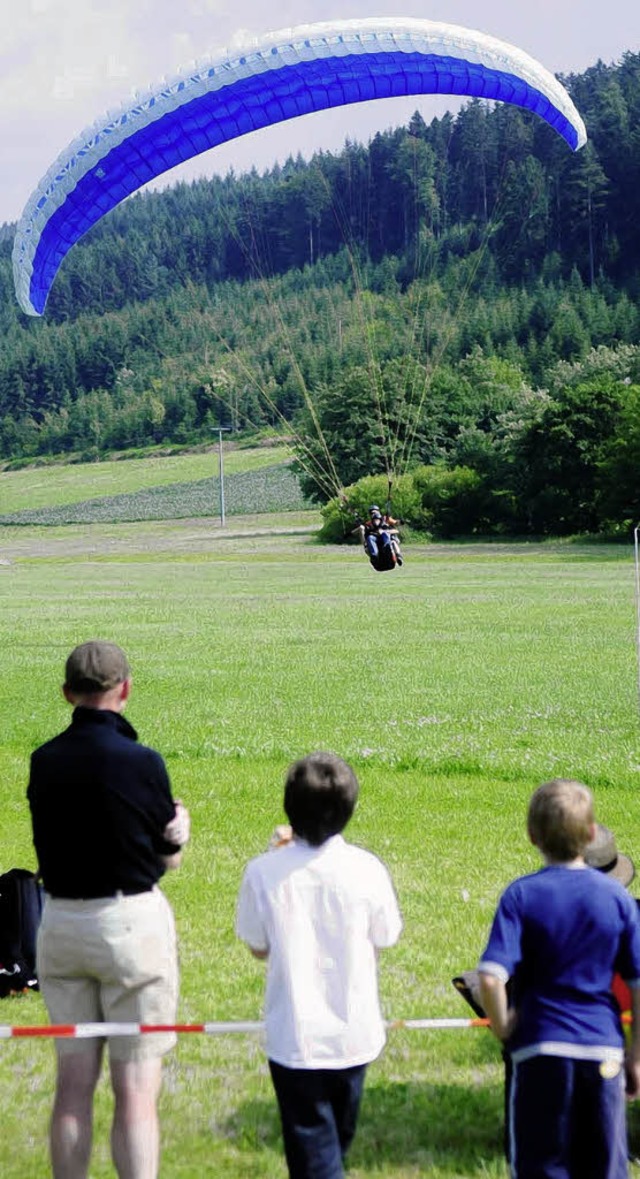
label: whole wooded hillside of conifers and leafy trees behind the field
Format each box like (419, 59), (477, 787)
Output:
(0, 53), (640, 535)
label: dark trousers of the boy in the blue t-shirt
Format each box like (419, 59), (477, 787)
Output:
(509, 1056), (628, 1179)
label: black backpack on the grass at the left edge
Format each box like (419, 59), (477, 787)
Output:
(0, 868), (42, 999)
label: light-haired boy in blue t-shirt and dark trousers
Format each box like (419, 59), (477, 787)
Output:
(479, 778), (640, 1179)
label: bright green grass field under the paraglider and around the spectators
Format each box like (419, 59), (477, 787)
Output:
(0, 473), (640, 1179)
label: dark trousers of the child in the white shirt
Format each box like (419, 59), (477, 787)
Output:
(269, 1060), (367, 1179)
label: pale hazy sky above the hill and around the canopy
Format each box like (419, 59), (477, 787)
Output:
(0, 0), (640, 224)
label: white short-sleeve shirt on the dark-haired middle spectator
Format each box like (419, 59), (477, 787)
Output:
(236, 835), (402, 1068)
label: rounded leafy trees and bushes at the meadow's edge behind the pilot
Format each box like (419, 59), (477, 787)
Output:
(311, 345), (640, 540)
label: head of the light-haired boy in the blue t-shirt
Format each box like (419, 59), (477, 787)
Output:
(527, 778), (595, 863)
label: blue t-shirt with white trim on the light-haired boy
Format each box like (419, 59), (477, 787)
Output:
(479, 864), (640, 1061)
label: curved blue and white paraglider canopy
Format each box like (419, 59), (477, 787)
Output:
(13, 18), (587, 315)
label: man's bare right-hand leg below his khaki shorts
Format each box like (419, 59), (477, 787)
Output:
(111, 1056), (163, 1179)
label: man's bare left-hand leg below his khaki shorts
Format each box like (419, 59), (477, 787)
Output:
(50, 1040), (103, 1179)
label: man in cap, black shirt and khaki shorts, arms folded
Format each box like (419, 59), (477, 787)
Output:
(27, 640), (189, 1179)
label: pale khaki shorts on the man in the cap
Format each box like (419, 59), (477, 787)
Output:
(37, 888), (178, 1060)
